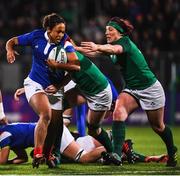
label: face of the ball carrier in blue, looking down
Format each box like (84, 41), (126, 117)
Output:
(48, 23), (66, 43)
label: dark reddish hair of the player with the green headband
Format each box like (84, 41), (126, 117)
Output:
(110, 17), (134, 35)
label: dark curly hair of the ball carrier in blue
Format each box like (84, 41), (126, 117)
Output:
(42, 13), (65, 29)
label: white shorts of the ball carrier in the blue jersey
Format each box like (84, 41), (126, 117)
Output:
(24, 77), (63, 110)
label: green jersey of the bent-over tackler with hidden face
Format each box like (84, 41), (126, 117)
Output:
(70, 52), (108, 95)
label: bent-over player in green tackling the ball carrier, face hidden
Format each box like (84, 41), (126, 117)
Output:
(46, 52), (121, 165)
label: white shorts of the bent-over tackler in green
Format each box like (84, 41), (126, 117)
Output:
(81, 84), (112, 111)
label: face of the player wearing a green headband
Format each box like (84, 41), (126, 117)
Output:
(105, 26), (121, 43)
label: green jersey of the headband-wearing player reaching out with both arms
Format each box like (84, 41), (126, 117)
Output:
(110, 36), (157, 90)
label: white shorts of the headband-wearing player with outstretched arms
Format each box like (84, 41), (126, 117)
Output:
(122, 80), (165, 110)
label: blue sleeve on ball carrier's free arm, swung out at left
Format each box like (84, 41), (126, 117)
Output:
(17, 31), (35, 46)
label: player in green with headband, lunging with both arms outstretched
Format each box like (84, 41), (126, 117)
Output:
(79, 17), (177, 167)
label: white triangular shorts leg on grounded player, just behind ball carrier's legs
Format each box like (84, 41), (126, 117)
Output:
(60, 125), (74, 153)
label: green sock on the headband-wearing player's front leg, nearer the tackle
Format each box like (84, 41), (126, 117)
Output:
(112, 121), (125, 156)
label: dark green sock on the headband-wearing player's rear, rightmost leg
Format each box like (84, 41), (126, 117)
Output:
(158, 126), (174, 156)
